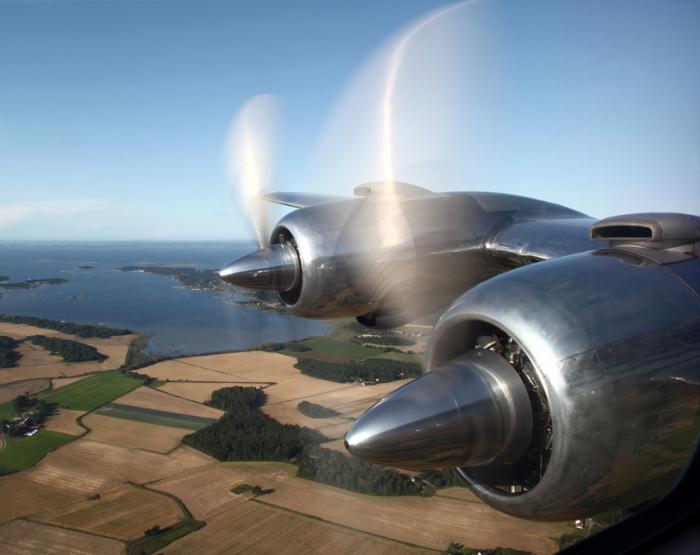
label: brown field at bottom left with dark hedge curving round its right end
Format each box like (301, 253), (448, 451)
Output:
(34, 485), (186, 541)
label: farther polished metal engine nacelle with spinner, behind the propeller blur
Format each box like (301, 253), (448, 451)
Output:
(220, 187), (591, 328)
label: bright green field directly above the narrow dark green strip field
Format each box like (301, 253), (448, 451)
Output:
(38, 371), (143, 411)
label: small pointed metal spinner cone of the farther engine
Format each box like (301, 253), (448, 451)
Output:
(219, 243), (300, 291)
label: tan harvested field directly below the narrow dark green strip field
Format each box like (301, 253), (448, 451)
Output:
(83, 412), (192, 457)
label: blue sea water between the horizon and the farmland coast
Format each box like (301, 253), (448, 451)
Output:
(0, 242), (329, 355)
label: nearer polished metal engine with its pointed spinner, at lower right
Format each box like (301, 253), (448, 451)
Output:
(346, 245), (700, 520)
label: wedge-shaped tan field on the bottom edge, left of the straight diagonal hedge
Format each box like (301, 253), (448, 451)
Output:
(163, 501), (426, 555)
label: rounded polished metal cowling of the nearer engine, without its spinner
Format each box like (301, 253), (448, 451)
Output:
(426, 249), (700, 520)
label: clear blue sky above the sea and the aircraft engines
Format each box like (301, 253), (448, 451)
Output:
(0, 0), (700, 240)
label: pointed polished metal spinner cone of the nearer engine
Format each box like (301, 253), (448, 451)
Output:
(345, 350), (532, 469)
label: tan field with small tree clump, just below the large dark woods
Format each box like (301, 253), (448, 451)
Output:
(150, 462), (296, 521)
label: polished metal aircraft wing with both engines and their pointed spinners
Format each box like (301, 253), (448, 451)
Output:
(221, 189), (700, 520)
